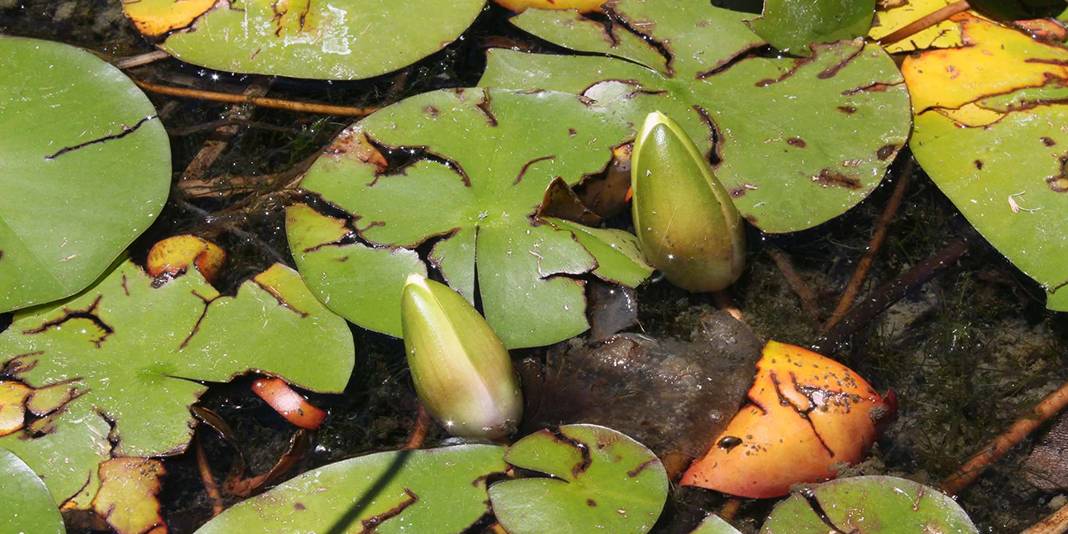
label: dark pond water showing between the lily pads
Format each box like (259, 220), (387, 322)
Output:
(0, 0), (1068, 533)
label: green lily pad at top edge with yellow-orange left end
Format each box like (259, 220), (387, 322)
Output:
(123, 0), (486, 80)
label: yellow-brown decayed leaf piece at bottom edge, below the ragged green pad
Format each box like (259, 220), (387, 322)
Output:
(92, 457), (167, 534)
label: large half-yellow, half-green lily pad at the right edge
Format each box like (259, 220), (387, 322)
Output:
(901, 14), (1068, 311)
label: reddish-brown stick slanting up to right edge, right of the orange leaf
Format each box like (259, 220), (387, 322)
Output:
(942, 382), (1068, 494)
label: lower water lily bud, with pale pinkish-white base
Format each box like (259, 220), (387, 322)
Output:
(401, 274), (523, 439)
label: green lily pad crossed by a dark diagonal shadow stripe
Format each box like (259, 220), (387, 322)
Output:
(197, 445), (507, 534)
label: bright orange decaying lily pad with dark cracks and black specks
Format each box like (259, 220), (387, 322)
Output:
(681, 342), (893, 499)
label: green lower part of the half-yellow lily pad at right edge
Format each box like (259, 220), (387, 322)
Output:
(911, 105), (1068, 311)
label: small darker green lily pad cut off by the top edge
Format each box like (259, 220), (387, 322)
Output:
(752, 0), (876, 56)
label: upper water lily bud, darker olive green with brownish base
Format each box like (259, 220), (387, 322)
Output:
(631, 112), (745, 292)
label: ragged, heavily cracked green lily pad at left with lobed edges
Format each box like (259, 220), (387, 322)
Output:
(0, 262), (354, 507)
